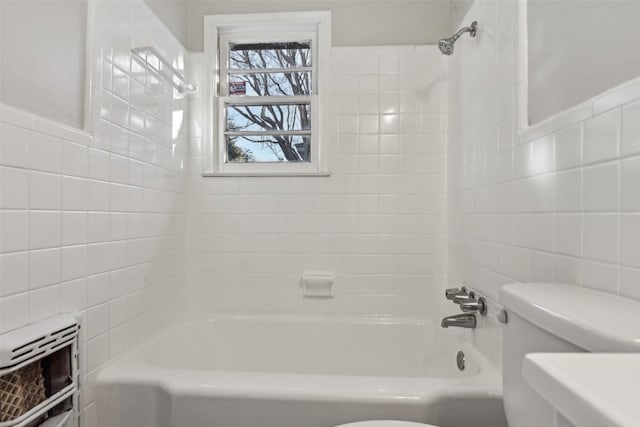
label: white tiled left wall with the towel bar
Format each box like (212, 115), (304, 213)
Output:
(0, 0), (187, 426)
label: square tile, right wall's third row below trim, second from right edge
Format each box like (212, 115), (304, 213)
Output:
(583, 214), (620, 263)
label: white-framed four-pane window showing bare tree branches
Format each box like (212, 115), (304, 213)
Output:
(204, 12), (330, 175)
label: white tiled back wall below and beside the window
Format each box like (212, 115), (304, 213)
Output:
(189, 46), (447, 315)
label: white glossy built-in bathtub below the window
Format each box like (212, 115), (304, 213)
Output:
(96, 315), (506, 427)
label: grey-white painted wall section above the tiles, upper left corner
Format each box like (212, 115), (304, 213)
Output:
(0, 0), (87, 128)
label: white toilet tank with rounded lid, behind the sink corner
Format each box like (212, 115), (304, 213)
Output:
(500, 283), (640, 427)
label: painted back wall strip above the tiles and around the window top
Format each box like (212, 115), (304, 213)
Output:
(187, 0), (450, 51)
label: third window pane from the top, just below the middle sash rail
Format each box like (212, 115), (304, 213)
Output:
(225, 104), (311, 132)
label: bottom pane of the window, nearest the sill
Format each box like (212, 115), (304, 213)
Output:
(227, 135), (311, 163)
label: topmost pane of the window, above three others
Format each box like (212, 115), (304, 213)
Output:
(229, 40), (311, 69)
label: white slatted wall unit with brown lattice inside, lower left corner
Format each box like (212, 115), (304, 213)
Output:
(0, 315), (79, 427)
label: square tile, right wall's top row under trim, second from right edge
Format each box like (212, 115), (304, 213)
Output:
(583, 110), (620, 164)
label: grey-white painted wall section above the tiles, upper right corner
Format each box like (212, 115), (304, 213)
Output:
(528, 0), (640, 123)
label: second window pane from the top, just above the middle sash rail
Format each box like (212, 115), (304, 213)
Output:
(229, 71), (311, 96)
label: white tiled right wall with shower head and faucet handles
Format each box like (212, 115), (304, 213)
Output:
(448, 0), (640, 372)
